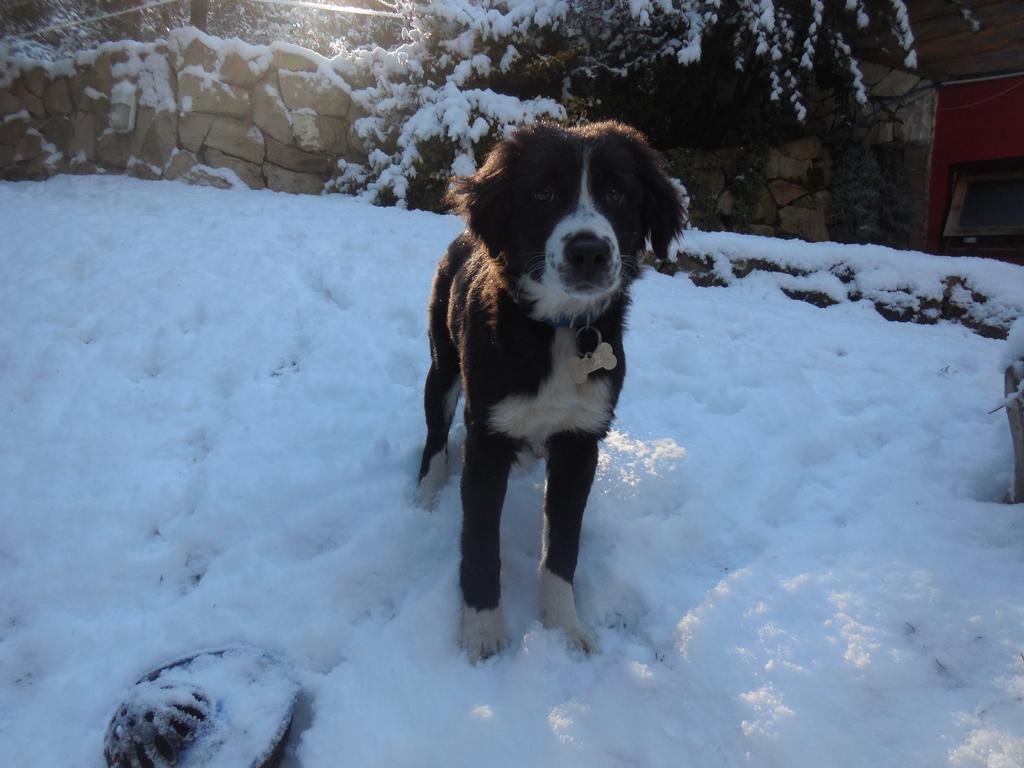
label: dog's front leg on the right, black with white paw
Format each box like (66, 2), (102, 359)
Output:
(541, 432), (598, 653)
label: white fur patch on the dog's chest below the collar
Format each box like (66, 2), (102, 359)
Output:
(488, 328), (611, 447)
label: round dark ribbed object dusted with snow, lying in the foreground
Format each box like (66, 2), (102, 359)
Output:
(103, 646), (299, 768)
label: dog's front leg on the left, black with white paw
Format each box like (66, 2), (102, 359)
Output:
(459, 427), (516, 663)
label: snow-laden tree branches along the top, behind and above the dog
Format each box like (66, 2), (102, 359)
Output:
(339, 0), (929, 207)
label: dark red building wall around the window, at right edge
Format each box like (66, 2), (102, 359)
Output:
(928, 75), (1024, 257)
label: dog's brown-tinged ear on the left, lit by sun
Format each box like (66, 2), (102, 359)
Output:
(444, 139), (518, 256)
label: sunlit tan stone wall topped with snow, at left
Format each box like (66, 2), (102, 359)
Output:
(0, 29), (366, 194)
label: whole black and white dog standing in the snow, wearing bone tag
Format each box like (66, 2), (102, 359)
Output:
(420, 122), (683, 660)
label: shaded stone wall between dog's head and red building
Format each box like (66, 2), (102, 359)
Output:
(667, 61), (936, 249)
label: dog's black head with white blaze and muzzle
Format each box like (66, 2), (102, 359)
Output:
(447, 122), (684, 319)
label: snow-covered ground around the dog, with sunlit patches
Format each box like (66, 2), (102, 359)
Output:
(0, 177), (1024, 768)
